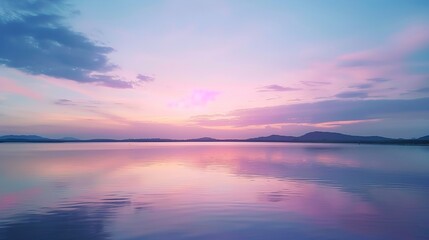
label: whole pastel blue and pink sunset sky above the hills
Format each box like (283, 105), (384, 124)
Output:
(0, 0), (429, 139)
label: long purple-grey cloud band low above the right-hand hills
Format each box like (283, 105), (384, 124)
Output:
(194, 98), (429, 127)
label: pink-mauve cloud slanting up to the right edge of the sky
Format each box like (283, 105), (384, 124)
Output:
(274, 24), (429, 101)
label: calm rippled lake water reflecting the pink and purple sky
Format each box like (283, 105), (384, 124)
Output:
(0, 143), (429, 240)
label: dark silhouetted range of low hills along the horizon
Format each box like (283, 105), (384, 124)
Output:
(0, 131), (429, 145)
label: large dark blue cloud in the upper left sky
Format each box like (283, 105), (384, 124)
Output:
(0, 0), (144, 88)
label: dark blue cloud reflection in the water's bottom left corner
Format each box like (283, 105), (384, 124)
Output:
(0, 199), (129, 240)
